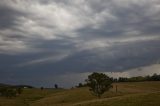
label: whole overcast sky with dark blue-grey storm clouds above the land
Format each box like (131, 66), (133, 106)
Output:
(0, 0), (160, 87)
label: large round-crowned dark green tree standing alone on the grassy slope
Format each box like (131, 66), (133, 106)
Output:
(86, 72), (112, 98)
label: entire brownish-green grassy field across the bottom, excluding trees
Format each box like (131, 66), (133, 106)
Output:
(0, 82), (160, 106)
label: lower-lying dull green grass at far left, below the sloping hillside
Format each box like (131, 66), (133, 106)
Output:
(0, 89), (64, 106)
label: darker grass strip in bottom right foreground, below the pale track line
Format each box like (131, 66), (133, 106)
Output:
(72, 92), (160, 106)
